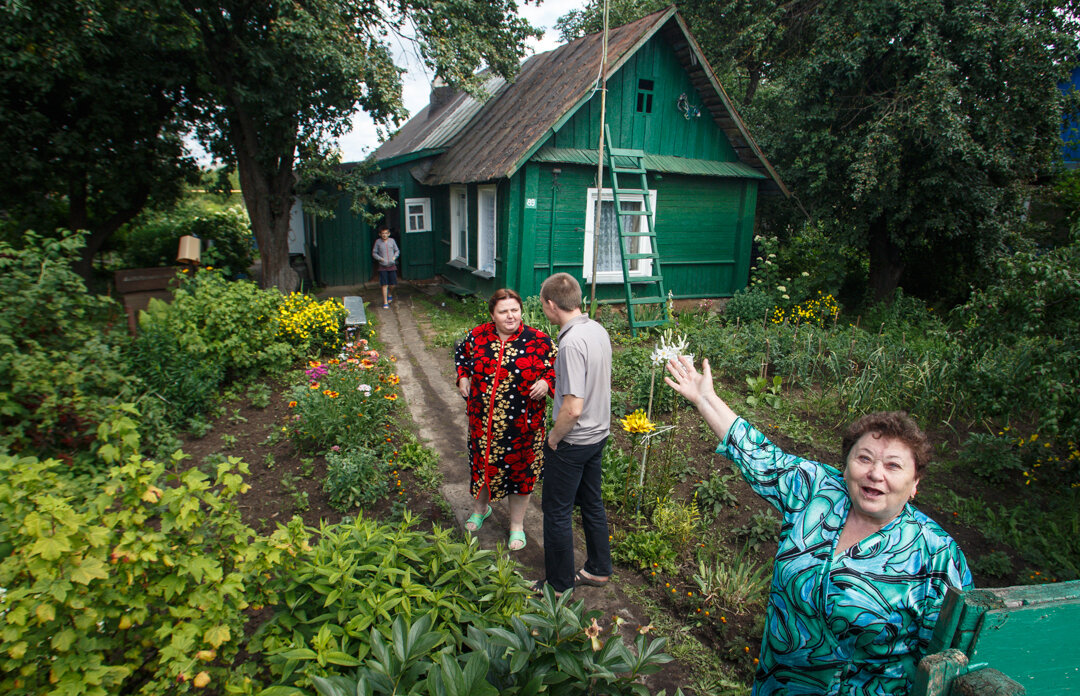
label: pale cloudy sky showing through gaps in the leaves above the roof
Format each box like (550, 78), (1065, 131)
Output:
(338, 0), (582, 162)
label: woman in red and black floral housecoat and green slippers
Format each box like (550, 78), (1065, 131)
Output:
(455, 290), (556, 551)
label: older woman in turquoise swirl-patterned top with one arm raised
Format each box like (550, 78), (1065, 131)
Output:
(664, 357), (972, 696)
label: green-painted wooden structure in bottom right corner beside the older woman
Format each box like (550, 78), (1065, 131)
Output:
(913, 580), (1080, 696)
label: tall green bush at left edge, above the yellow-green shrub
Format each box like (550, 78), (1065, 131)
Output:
(0, 232), (139, 470)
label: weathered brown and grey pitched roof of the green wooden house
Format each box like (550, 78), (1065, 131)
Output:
(375, 6), (788, 195)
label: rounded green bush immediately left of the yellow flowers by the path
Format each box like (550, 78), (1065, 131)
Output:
(139, 270), (295, 382)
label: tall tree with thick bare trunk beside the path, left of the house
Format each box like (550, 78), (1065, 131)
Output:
(177, 0), (544, 291)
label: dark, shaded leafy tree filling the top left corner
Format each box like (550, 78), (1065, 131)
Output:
(0, 0), (197, 278)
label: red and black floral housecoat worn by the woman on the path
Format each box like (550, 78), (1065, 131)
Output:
(455, 322), (557, 500)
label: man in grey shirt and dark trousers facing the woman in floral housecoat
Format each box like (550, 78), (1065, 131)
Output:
(536, 273), (611, 592)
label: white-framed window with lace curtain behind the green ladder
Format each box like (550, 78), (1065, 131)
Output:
(582, 188), (657, 283)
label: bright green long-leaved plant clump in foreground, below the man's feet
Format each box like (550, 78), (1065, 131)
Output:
(249, 514), (527, 686)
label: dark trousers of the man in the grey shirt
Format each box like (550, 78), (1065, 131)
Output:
(541, 438), (611, 592)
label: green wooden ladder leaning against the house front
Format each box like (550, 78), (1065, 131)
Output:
(594, 123), (667, 336)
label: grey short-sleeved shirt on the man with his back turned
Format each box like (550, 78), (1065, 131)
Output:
(553, 314), (611, 444)
